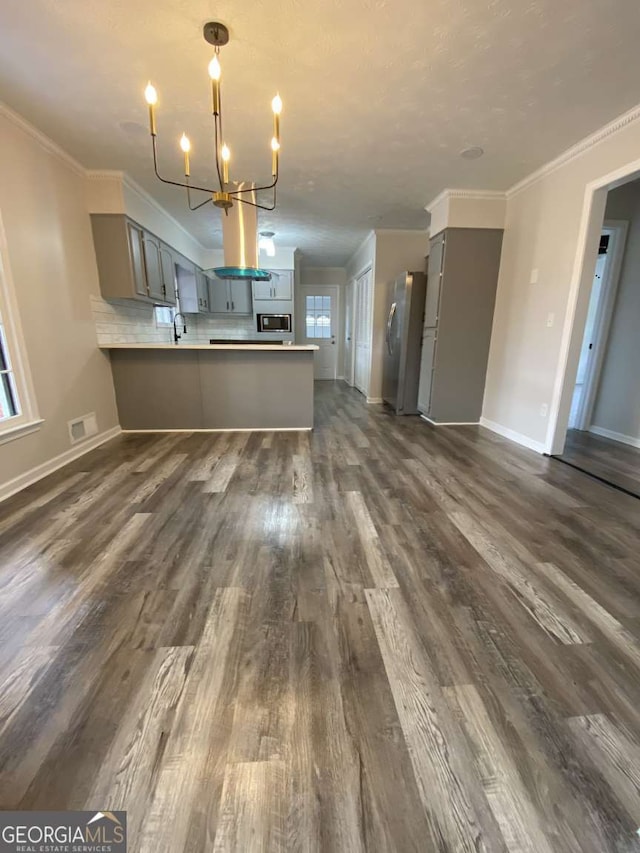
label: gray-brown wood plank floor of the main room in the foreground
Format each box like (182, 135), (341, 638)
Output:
(0, 383), (640, 853)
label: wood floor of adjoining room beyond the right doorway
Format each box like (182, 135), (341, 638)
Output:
(557, 429), (640, 498)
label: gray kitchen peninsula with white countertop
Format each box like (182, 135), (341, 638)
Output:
(100, 343), (318, 431)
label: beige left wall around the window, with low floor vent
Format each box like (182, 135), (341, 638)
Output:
(0, 107), (118, 493)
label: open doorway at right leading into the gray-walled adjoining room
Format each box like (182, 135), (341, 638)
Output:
(555, 179), (640, 497)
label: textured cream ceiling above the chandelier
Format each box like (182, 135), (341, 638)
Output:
(0, 0), (640, 265)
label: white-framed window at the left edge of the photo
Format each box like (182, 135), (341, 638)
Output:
(0, 210), (42, 444)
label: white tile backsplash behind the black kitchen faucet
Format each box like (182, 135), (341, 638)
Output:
(91, 296), (255, 344)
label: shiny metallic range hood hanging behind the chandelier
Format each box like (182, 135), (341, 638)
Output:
(213, 183), (271, 281)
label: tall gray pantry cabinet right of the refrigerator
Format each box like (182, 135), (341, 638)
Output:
(418, 228), (503, 423)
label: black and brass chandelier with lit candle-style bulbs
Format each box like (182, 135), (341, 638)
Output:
(144, 21), (282, 214)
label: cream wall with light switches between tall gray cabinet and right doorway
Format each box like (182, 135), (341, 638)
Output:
(483, 105), (640, 450)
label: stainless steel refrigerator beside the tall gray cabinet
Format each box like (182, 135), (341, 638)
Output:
(382, 272), (427, 415)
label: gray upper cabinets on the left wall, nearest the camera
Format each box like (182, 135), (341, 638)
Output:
(91, 213), (176, 305)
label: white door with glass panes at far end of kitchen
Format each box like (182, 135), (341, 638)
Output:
(303, 285), (338, 379)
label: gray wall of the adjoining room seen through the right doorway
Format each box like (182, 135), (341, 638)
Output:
(592, 181), (640, 444)
